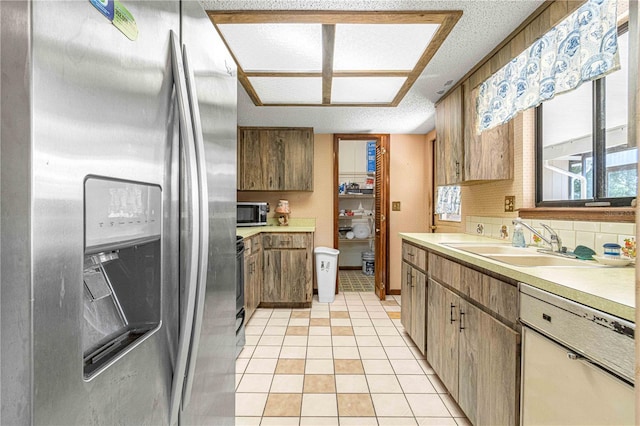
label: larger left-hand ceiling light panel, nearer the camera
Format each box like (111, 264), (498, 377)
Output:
(218, 24), (322, 72)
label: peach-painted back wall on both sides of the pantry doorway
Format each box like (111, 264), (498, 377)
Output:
(238, 134), (431, 292)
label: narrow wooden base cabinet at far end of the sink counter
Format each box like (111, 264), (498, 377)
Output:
(400, 242), (427, 354)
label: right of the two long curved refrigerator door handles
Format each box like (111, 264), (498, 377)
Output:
(182, 45), (209, 409)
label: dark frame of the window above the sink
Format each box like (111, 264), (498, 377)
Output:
(535, 23), (637, 208)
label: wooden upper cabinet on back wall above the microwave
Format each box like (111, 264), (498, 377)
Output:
(238, 127), (313, 191)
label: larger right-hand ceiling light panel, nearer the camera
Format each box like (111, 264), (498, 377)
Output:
(333, 24), (439, 71)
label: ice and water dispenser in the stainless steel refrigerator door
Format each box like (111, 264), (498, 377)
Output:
(82, 177), (162, 379)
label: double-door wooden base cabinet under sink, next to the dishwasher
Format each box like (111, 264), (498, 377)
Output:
(427, 253), (520, 425)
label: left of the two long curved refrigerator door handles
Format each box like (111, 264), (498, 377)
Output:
(169, 31), (200, 425)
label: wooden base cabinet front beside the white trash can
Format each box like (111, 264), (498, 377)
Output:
(260, 232), (313, 308)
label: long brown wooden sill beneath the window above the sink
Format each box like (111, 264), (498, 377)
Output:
(518, 207), (636, 223)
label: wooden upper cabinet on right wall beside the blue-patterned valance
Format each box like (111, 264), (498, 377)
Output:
(436, 81), (514, 185)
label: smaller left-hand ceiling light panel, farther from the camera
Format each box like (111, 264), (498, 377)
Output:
(249, 77), (322, 105)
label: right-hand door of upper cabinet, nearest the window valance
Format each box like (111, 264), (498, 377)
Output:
(462, 83), (513, 181)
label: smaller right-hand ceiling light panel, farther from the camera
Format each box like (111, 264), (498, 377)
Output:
(331, 77), (407, 104)
